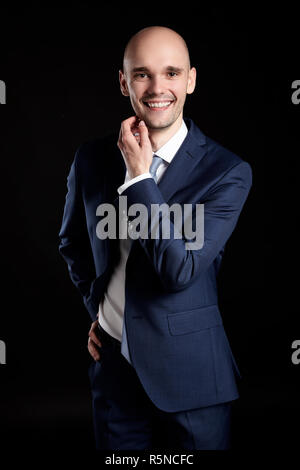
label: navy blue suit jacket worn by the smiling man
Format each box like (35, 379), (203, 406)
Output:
(59, 119), (252, 412)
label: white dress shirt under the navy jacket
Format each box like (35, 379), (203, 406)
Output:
(98, 120), (188, 342)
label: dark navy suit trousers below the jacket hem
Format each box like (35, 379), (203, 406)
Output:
(89, 325), (232, 450)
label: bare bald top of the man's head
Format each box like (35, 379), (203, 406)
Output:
(123, 26), (191, 73)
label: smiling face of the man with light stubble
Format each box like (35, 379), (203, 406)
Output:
(120, 37), (196, 129)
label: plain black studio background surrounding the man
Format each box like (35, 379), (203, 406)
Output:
(0, 2), (300, 455)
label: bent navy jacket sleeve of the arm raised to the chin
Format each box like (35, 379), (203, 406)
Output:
(123, 161), (252, 291)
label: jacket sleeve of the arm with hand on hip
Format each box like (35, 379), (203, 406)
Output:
(59, 147), (97, 320)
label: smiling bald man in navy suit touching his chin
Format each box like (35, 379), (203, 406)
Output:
(60, 27), (251, 450)
